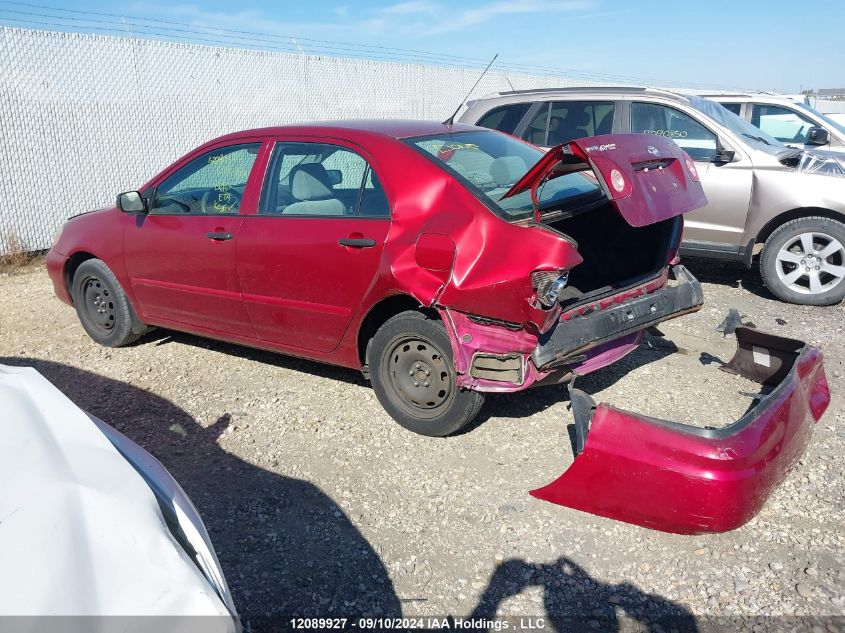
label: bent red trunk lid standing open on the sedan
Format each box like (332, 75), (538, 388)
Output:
(502, 134), (707, 227)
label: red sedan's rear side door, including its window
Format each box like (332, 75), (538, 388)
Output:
(237, 138), (390, 355)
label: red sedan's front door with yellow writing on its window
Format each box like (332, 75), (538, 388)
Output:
(124, 142), (261, 337)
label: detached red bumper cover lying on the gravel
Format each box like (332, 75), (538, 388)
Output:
(531, 327), (830, 534)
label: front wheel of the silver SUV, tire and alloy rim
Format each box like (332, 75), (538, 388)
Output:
(760, 216), (845, 306)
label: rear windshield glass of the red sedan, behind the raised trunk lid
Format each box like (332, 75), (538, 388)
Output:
(405, 130), (604, 222)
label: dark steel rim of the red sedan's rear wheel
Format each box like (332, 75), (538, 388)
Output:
(387, 335), (455, 419)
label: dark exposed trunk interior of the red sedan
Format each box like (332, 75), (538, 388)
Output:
(547, 203), (680, 307)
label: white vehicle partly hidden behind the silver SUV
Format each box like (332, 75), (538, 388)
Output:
(698, 92), (845, 154)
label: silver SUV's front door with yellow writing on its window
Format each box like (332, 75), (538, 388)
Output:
(630, 101), (753, 247)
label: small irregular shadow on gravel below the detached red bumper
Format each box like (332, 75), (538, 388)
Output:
(469, 557), (698, 633)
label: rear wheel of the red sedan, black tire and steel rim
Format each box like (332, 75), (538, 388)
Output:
(367, 311), (484, 437)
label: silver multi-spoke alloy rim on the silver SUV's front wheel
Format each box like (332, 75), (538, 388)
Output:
(775, 231), (845, 295)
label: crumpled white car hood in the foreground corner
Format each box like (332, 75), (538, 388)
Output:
(0, 365), (238, 630)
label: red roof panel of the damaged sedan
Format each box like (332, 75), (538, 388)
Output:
(214, 119), (478, 142)
